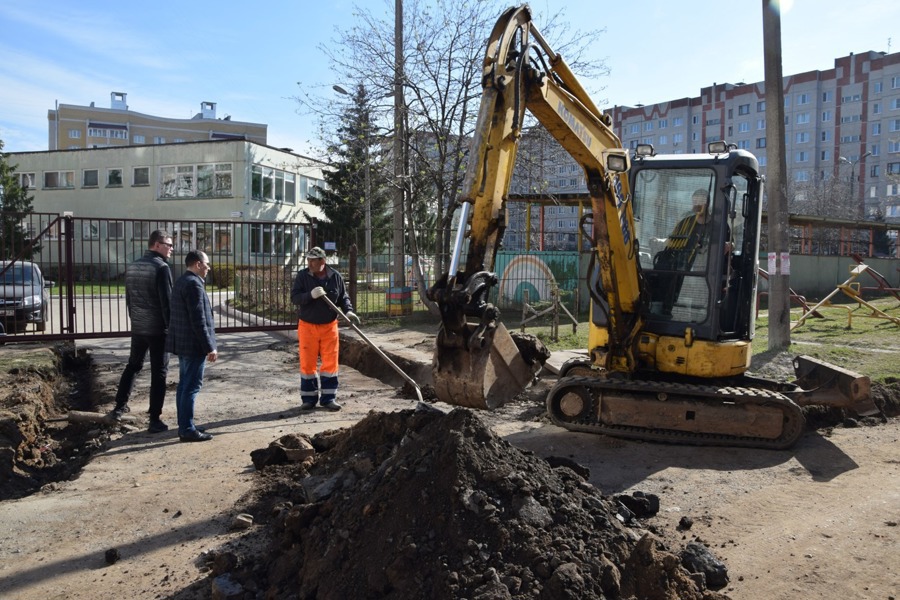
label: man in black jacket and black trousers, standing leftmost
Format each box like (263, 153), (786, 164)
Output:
(112, 229), (172, 433)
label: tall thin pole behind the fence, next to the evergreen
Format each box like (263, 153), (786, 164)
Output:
(393, 0), (406, 287)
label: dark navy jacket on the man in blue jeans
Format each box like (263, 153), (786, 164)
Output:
(166, 271), (216, 356)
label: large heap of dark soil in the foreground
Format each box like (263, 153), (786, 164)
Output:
(229, 408), (727, 600)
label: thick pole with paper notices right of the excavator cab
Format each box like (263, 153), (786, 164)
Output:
(762, 0), (791, 350)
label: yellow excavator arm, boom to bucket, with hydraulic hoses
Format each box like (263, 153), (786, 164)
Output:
(428, 6), (644, 408)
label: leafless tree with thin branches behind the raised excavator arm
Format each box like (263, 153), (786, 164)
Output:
(306, 0), (607, 272)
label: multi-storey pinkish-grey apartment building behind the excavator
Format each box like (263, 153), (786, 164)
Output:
(507, 51), (900, 249)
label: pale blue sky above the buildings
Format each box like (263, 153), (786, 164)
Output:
(0, 0), (900, 156)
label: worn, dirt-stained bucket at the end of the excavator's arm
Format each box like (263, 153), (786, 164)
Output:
(432, 323), (535, 410)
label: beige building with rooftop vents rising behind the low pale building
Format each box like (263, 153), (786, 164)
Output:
(47, 92), (268, 150)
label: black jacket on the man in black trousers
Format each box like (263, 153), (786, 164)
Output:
(125, 250), (172, 335)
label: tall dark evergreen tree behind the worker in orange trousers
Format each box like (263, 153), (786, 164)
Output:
(310, 84), (391, 254)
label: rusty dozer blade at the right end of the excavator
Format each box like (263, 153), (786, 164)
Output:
(789, 356), (879, 416)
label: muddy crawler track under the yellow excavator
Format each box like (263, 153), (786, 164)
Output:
(547, 376), (805, 450)
